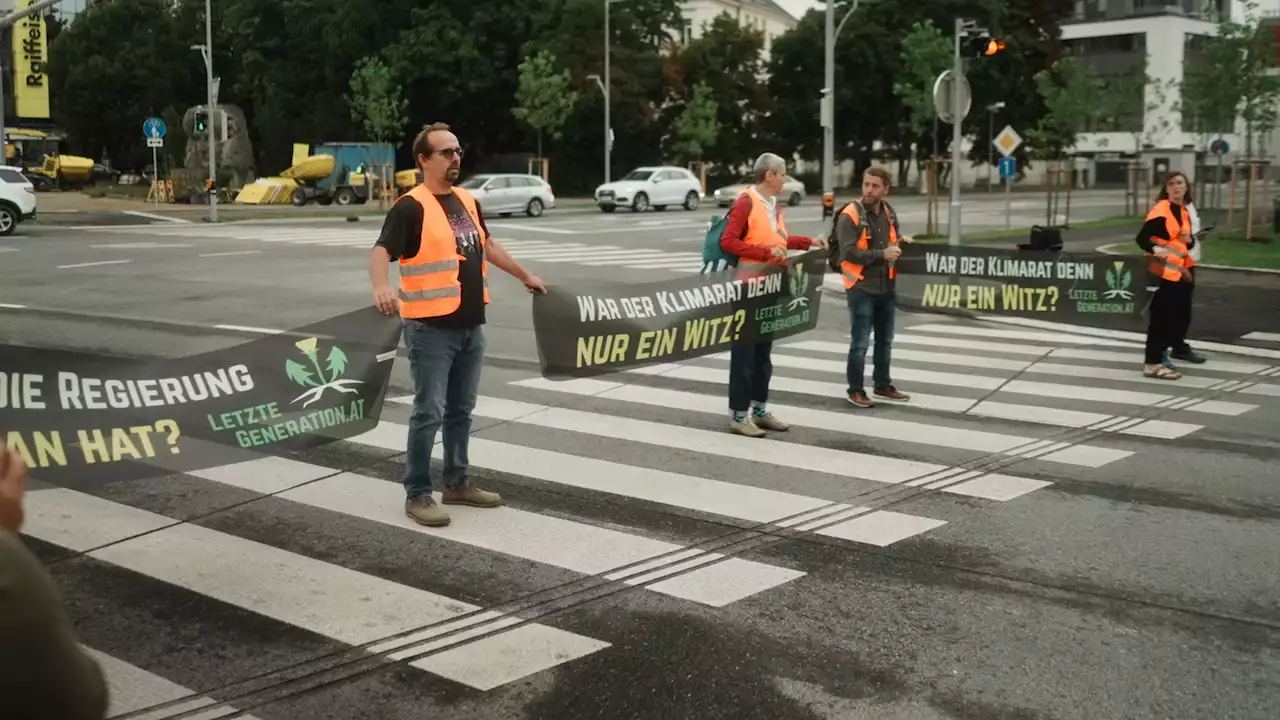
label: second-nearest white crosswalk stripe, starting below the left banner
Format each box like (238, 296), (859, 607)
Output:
(23, 480), (609, 691)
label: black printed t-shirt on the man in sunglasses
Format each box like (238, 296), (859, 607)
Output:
(378, 192), (489, 329)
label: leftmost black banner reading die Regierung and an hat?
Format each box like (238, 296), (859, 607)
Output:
(0, 307), (401, 483)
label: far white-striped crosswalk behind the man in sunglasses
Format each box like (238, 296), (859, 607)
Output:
(83, 223), (703, 273)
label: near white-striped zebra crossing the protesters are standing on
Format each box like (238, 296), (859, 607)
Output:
(32, 323), (1280, 717)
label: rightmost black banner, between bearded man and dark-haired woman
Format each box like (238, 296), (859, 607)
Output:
(896, 243), (1147, 317)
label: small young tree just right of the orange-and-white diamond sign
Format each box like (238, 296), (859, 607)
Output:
(1028, 55), (1105, 158)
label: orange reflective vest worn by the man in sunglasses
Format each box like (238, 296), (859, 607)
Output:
(396, 184), (489, 319)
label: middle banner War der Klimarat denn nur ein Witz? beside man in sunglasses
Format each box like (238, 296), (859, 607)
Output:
(534, 251), (826, 377)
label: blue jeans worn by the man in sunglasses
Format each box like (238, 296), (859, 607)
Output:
(404, 320), (485, 498)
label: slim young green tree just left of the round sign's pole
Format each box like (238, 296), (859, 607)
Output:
(893, 20), (952, 184)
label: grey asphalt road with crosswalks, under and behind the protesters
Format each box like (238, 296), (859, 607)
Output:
(0, 192), (1280, 720)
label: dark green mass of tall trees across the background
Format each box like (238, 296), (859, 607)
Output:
(50, 0), (1090, 192)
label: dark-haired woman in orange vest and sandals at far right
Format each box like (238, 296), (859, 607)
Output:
(1137, 170), (1204, 380)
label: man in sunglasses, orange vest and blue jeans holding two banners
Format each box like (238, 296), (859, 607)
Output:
(369, 123), (547, 527)
